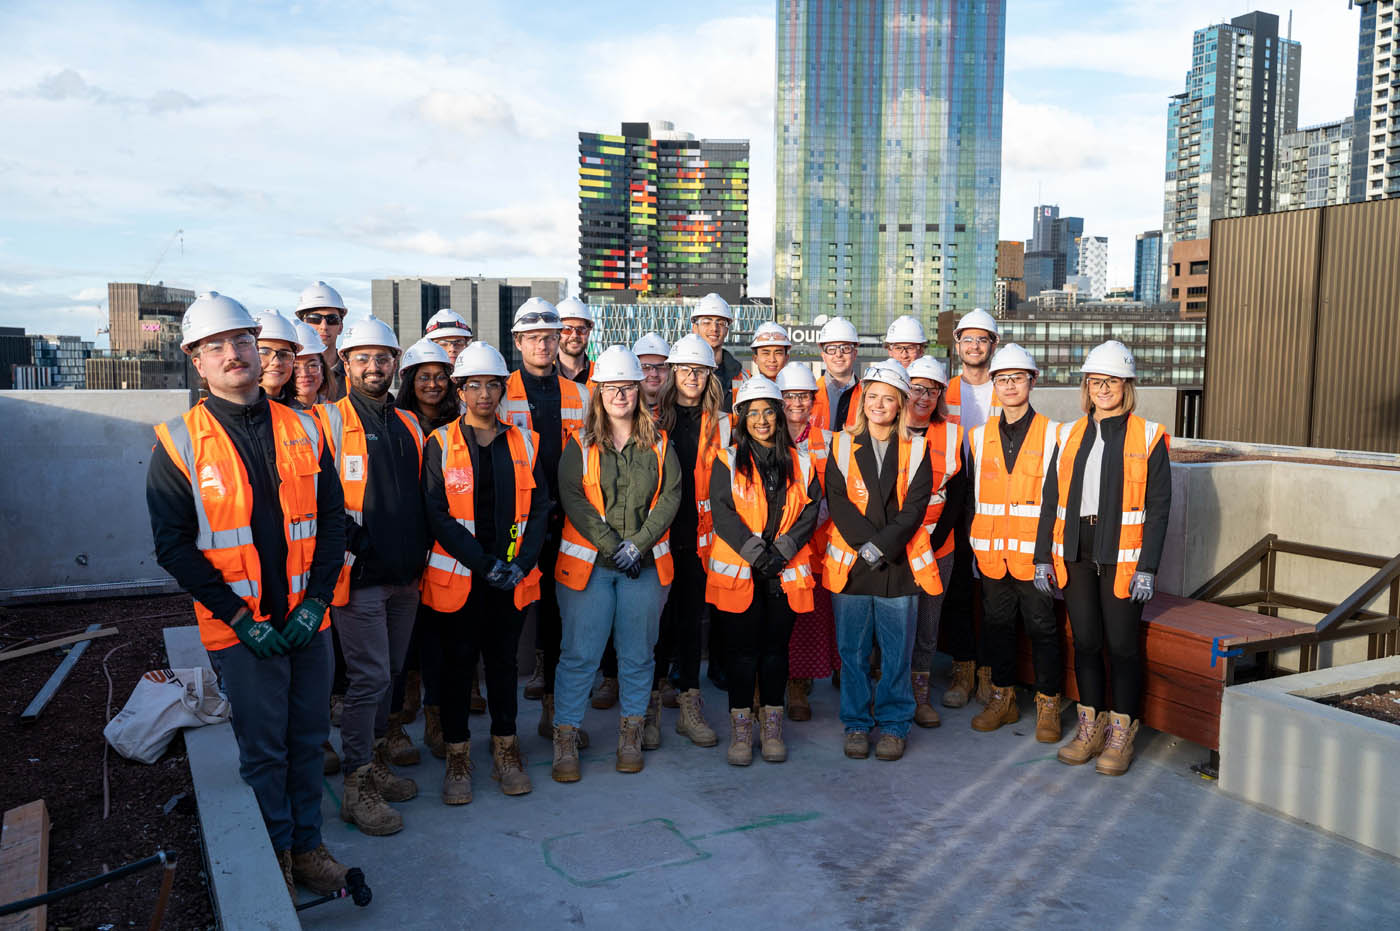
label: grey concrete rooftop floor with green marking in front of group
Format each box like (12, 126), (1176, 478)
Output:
(301, 663), (1400, 930)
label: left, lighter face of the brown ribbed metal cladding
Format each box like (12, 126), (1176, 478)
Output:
(1201, 210), (1322, 447)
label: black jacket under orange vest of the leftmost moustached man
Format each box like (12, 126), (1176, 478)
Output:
(146, 395), (346, 629)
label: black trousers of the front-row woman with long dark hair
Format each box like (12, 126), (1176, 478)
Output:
(710, 580), (794, 708)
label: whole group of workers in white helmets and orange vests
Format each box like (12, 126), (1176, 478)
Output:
(147, 281), (1170, 899)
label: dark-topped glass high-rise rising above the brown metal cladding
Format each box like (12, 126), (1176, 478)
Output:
(1162, 13), (1302, 282)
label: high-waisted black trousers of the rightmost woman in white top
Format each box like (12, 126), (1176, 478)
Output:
(1064, 521), (1142, 718)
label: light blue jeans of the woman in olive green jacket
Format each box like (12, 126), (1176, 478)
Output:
(554, 566), (669, 727)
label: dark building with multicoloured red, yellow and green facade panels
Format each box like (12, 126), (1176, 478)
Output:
(578, 120), (749, 302)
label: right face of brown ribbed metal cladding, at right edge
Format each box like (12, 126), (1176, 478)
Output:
(1309, 197), (1400, 452)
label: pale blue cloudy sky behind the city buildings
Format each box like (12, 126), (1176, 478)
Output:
(0, 0), (1359, 344)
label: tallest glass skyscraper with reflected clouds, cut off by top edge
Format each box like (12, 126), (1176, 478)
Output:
(774, 0), (1007, 332)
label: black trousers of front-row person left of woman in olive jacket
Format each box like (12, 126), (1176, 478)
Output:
(430, 580), (525, 743)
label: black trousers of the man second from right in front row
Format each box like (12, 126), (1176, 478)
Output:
(981, 573), (1064, 694)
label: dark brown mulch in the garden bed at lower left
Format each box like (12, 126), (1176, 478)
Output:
(0, 595), (214, 930)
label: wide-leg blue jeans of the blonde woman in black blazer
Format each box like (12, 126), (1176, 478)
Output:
(832, 592), (918, 738)
